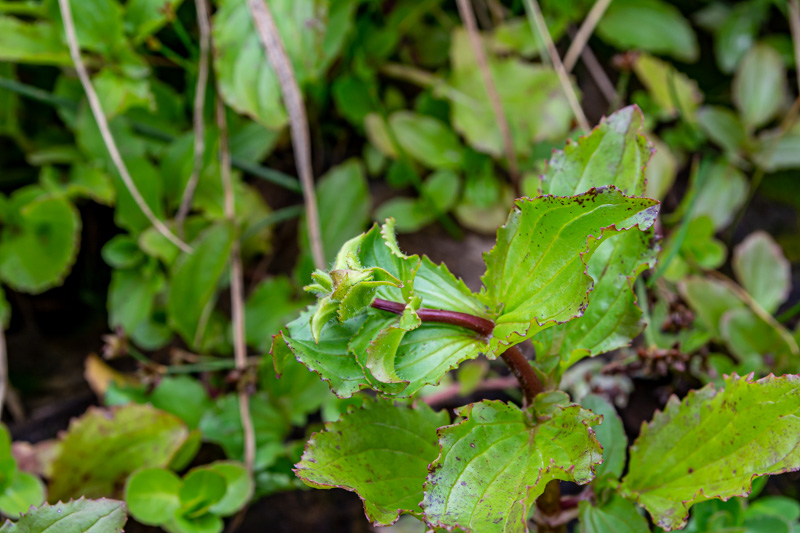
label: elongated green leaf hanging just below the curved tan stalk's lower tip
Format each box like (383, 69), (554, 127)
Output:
(167, 222), (233, 346)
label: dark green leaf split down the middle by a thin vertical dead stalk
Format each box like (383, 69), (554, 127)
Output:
(200, 393), (289, 469)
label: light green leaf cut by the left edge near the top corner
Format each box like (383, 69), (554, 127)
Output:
(0, 16), (72, 65)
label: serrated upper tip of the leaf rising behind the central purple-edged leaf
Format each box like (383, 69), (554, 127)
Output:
(542, 105), (654, 196)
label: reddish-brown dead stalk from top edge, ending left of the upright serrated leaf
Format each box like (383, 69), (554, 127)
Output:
(457, 0), (520, 196)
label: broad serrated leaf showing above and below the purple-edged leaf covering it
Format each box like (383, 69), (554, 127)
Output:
(537, 106), (657, 370)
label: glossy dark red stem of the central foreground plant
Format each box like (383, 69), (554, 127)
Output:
(372, 298), (544, 405)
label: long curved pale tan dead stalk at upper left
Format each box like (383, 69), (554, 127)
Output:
(58, 0), (192, 253)
